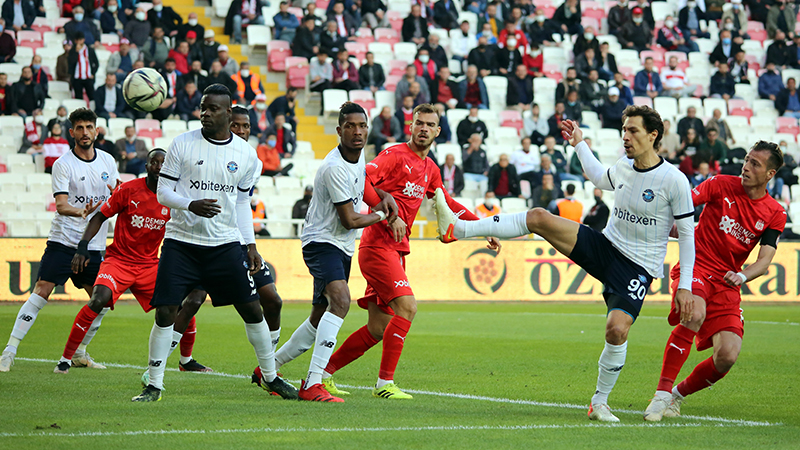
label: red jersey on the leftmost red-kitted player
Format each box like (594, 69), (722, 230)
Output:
(100, 178), (170, 264)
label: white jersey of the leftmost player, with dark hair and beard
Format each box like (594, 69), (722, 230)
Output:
(48, 149), (119, 251)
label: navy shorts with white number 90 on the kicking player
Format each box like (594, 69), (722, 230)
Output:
(569, 225), (653, 321)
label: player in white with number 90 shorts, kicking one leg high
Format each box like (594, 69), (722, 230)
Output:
(436, 106), (694, 422)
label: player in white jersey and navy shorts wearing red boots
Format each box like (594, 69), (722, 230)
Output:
(260, 102), (398, 403)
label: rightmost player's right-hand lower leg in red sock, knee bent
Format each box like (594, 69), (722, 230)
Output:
(664, 331), (742, 417)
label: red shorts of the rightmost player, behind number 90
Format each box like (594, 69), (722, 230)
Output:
(669, 270), (744, 351)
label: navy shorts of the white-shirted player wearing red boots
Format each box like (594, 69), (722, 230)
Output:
(303, 242), (352, 305)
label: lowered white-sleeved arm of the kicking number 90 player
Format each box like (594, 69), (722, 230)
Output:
(670, 173), (695, 322)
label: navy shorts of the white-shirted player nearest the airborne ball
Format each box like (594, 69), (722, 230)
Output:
(150, 239), (258, 306)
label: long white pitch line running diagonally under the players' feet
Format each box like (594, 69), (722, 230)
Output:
(12, 358), (783, 427)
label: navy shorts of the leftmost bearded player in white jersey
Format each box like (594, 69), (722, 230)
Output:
(36, 241), (103, 289)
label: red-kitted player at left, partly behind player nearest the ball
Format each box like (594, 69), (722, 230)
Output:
(54, 148), (211, 373)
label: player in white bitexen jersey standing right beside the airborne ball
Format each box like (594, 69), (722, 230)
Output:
(132, 84), (297, 402)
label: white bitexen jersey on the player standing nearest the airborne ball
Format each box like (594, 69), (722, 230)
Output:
(160, 129), (261, 247)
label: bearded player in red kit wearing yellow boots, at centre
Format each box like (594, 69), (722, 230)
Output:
(323, 104), (500, 399)
